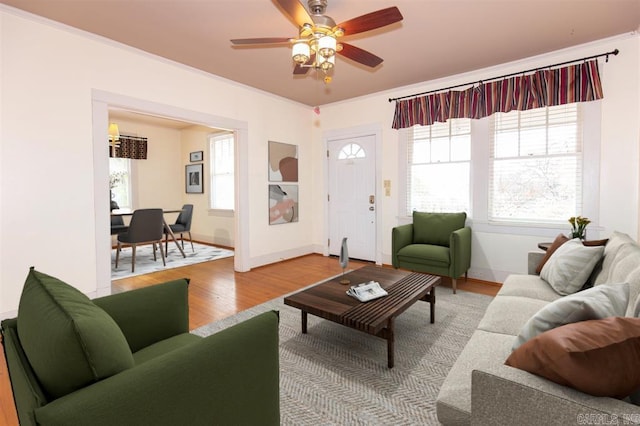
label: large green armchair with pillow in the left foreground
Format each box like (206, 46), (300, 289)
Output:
(2, 268), (280, 426)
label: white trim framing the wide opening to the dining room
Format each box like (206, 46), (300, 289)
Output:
(91, 89), (251, 295)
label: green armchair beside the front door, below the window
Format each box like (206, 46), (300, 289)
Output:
(391, 211), (471, 294)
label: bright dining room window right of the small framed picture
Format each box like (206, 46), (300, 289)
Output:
(209, 133), (235, 210)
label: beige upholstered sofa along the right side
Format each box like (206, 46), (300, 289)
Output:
(436, 232), (640, 425)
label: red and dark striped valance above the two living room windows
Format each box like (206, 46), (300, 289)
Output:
(392, 60), (603, 129)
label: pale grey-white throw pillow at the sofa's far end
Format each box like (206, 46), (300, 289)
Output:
(540, 238), (604, 296)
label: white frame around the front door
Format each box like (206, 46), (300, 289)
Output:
(322, 124), (383, 265)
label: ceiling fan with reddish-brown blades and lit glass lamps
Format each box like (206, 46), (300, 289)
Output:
(231, 0), (402, 83)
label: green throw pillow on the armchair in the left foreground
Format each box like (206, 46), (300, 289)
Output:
(18, 267), (134, 399)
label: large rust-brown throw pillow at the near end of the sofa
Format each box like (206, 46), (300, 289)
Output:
(505, 317), (640, 399)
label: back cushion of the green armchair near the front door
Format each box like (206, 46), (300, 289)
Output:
(413, 211), (467, 247)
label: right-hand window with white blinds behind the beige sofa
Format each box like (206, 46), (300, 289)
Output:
(488, 104), (582, 223)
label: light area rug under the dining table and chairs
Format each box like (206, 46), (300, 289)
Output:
(111, 242), (233, 280)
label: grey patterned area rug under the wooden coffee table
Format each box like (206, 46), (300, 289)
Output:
(193, 288), (492, 426)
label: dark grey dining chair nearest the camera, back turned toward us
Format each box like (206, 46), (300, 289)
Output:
(116, 209), (167, 272)
